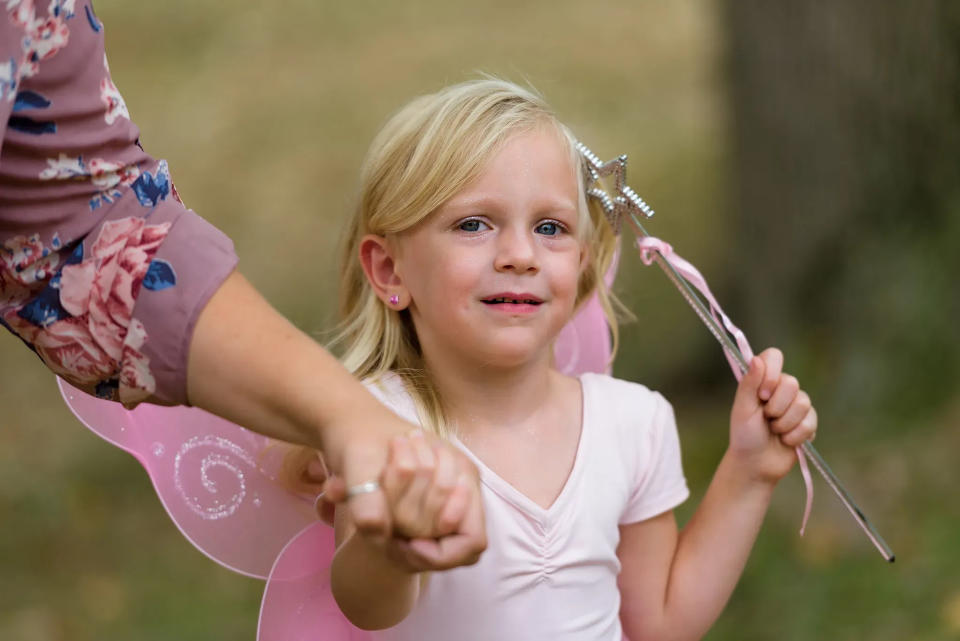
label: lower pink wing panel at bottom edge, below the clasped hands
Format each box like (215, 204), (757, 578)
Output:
(257, 521), (373, 641)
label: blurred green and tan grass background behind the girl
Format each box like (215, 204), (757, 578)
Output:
(0, 0), (960, 641)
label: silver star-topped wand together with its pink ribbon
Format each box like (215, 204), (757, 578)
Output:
(577, 143), (895, 563)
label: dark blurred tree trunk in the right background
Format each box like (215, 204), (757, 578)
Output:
(722, 0), (960, 424)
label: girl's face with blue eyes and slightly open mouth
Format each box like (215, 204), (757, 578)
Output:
(394, 127), (584, 367)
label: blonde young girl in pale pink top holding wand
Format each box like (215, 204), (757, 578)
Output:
(331, 80), (816, 641)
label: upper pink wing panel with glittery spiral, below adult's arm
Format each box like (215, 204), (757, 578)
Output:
(58, 379), (317, 578)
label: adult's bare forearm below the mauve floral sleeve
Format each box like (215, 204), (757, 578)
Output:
(187, 271), (418, 532)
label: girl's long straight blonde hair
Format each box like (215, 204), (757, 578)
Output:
(331, 78), (619, 436)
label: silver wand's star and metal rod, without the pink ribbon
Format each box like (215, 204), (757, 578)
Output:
(577, 143), (894, 563)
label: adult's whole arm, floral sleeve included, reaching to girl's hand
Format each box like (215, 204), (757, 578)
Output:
(0, 0), (482, 562)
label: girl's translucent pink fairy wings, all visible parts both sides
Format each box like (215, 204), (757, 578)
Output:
(58, 249), (616, 641)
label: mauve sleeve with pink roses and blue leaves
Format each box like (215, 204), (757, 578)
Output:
(0, 0), (236, 406)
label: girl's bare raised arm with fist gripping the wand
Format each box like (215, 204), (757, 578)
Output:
(617, 350), (816, 641)
